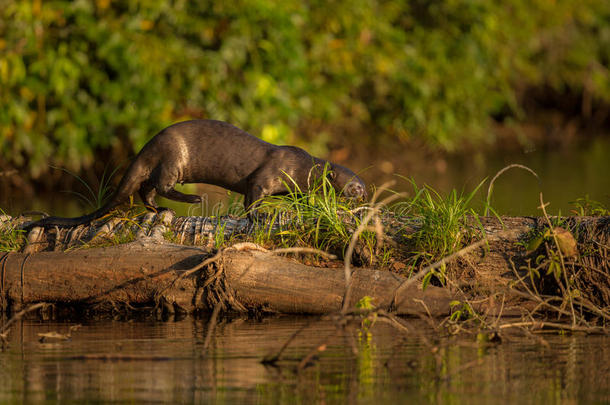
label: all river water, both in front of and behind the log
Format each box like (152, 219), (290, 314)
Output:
(0, 137), (610, 404)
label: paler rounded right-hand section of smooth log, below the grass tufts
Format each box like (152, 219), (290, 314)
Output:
(224, 252), (453, 316)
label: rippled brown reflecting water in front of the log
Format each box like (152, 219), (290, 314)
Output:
(0, 317), (610, 404)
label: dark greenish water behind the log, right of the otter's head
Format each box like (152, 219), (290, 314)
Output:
(371, 136), (610, 216)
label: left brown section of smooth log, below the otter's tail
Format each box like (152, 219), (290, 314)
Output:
(2, 241), (208, 308)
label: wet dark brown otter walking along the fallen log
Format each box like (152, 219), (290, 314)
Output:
(26, 120), (366, 229)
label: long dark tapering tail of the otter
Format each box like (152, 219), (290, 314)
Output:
(23, 158), (148, 231)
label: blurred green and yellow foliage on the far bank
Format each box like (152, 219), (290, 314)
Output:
(0, 0), (610, 177)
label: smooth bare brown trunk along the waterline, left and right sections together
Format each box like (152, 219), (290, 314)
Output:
(3, 241), (452, 316)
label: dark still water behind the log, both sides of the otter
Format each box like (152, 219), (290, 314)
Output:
(0, 135), (610, 216)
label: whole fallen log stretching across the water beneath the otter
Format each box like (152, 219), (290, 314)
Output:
(0, 217), (610, 319)
